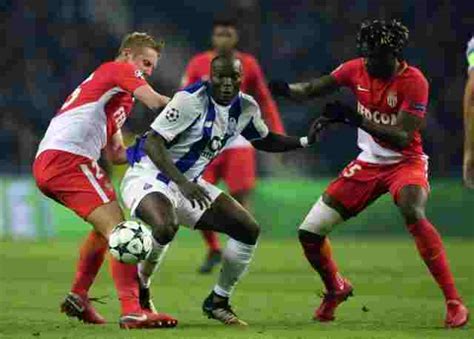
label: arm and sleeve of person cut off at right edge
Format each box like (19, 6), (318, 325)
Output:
(463, 37), (474, 189)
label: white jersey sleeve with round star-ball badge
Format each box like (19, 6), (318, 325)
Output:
(150, 92), (199, 142)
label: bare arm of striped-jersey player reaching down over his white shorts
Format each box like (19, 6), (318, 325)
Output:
(145, 132), (211, 209)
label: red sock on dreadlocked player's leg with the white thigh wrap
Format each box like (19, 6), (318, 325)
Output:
(300, 234), (341, 291)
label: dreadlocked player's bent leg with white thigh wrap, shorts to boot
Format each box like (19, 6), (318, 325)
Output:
(298, 163), (383, 321)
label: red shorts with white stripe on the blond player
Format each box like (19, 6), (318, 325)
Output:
(33, 150), (116, 219)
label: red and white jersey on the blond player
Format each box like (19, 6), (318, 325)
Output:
(37, 61), (147, 160)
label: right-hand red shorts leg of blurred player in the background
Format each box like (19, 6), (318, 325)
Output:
(222, 147), (256, 196)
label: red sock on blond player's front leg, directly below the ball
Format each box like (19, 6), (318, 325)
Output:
(110, 257), (141, 314)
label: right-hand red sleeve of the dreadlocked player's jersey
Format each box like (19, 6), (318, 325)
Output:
(400, 73), (429, 118)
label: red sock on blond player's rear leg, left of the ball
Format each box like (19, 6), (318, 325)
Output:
(71, 231), (107, 296)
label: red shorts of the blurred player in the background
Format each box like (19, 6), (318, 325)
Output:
(203, 147), (256, 194)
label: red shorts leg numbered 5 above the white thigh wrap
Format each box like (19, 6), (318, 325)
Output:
(322, 161), (387, 220)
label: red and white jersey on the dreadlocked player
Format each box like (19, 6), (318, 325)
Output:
(331, 58), (428, 163)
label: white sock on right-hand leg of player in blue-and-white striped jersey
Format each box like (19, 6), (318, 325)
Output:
(214, 238), (256, 298)
